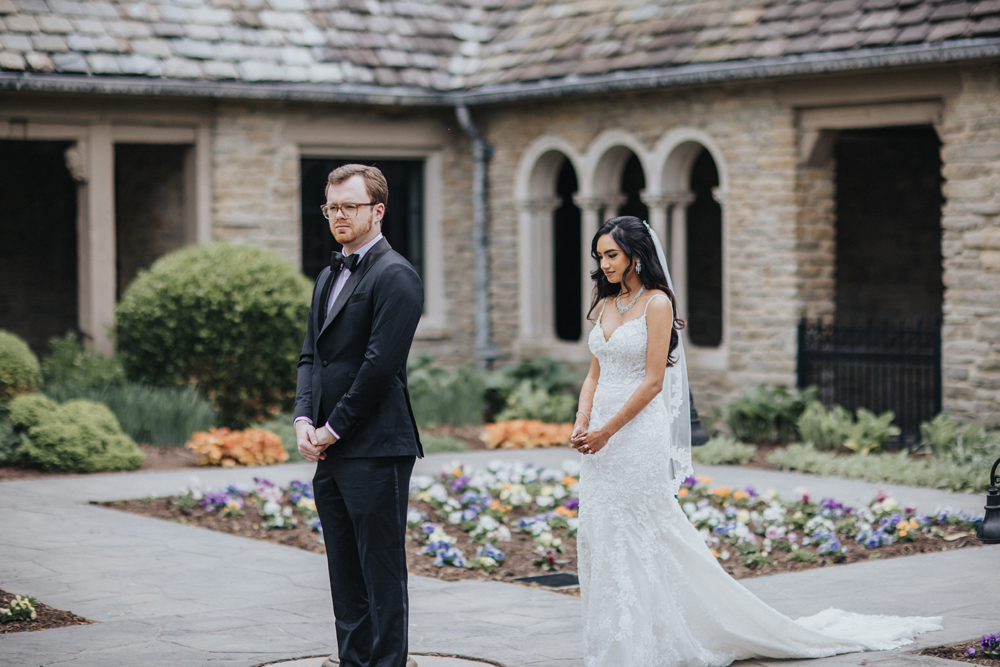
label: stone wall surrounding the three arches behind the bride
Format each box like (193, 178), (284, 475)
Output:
(477, 88), (800, 409)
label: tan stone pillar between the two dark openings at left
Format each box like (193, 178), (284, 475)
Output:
(77, 125), (116, 354)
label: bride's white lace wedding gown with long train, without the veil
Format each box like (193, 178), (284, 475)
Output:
(577, 298), (941, 667)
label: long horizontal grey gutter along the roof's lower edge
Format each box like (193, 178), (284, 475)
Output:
(0, 37), (1000, 109)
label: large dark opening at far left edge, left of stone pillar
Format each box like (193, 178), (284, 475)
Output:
(0, 141), (78, 354)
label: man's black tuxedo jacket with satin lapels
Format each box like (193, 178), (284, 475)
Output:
(295, 239), (424, 458)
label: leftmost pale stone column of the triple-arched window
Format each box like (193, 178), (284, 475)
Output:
(517, 197), (562, 345)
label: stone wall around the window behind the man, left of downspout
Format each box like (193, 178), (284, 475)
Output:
(212, 103), (475, 365)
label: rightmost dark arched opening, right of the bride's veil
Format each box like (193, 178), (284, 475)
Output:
(687, 149), (722, 347)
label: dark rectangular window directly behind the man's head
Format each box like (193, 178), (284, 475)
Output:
(302, 157), (424, 278)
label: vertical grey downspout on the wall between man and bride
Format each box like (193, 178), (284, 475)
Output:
(455, 103), (497, 368)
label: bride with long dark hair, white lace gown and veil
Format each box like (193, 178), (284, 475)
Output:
(571, 216), (941, 667)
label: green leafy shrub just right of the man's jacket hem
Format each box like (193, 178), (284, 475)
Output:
(406, 357), (485, 428)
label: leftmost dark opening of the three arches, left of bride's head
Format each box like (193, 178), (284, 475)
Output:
(552, 160), (583, 341)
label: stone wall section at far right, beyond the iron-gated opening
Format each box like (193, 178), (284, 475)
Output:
(940, 67), (1000, 426)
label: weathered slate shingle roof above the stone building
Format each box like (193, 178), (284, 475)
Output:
(0, 0), (1000, 102)
